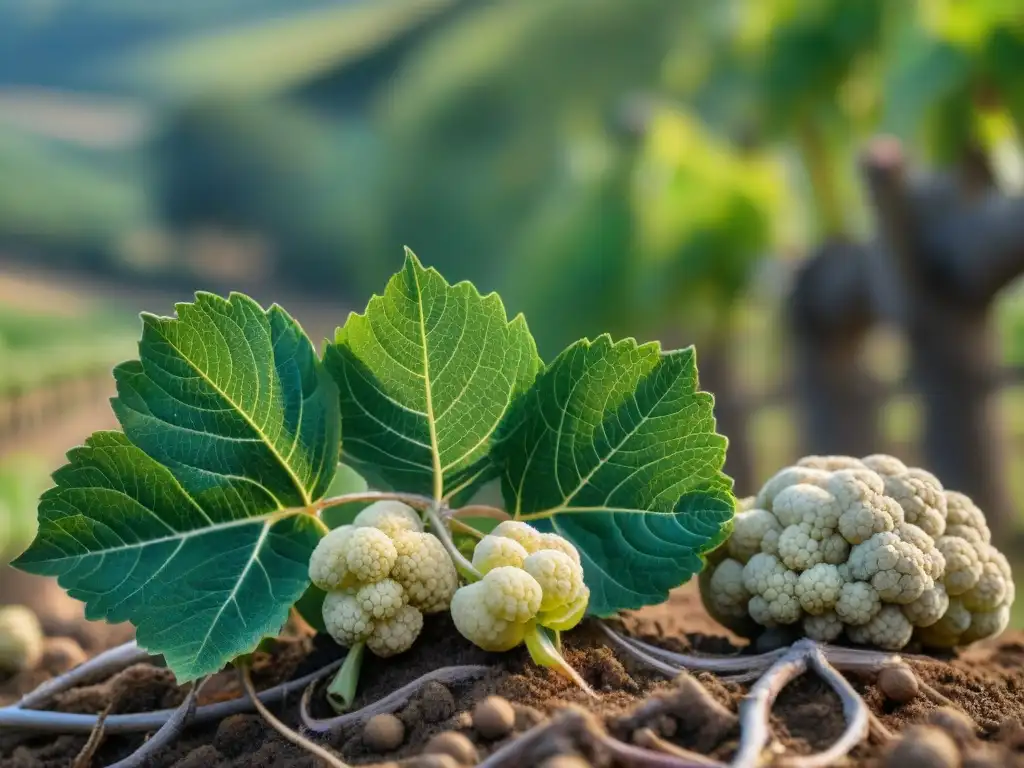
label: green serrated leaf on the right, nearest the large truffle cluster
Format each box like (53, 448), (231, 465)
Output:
(493, 336), (735, 616)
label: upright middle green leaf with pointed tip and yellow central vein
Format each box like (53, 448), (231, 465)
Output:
(324, 251), (541, 500)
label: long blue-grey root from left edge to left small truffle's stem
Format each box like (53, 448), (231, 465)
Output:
(0, 658), (344, 733)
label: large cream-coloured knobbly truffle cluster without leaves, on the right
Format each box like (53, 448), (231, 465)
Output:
(700, 455), (1014, 650)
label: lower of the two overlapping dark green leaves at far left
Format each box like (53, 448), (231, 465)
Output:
(13, 432), (321, 682)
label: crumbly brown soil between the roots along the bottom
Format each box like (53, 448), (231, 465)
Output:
(0, 588), (1024, 768)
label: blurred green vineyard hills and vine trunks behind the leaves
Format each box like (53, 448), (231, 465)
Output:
(0, 0), (1024, 626)
